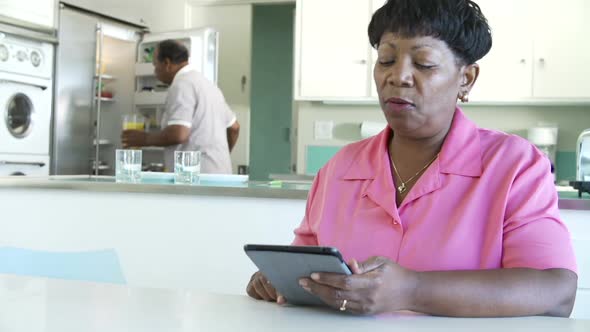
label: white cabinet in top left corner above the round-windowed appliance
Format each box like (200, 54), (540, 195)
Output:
(0, 0), (56, 29)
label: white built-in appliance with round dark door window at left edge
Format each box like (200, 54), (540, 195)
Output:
(0, 33), (53, 176)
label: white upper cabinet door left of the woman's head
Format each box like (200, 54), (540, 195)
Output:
(297, 0), (369, 98)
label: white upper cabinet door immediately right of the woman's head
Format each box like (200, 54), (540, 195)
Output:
(469, 0), (533, 101)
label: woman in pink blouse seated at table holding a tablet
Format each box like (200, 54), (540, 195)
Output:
(247, 0), (577, 317)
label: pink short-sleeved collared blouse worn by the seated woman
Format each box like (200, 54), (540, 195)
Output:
(293, 109), (576, 272)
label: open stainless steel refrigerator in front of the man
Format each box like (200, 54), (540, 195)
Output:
(50, 3), (218, 175)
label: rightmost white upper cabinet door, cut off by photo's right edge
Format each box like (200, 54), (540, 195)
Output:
(534, 0), (590, 98)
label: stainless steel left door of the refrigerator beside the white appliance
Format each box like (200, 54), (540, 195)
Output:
(51, 8), (97, 175)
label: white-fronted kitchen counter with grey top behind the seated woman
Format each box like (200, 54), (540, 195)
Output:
(0, 176), (590, 318)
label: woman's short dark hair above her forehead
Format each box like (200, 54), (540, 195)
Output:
(369, 0), (492, 64)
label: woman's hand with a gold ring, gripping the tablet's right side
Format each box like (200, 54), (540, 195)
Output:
(299, 257), (417, 315)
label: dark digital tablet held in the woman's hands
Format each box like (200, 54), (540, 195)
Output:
(244, 244), (351, 305)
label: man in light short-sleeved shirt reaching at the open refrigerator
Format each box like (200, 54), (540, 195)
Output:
(121, 40), (240, 174)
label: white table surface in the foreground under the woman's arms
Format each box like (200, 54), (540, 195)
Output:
(0, 275), (590, 332)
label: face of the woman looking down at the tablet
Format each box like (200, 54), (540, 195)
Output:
(374, 33), (479, 139)
